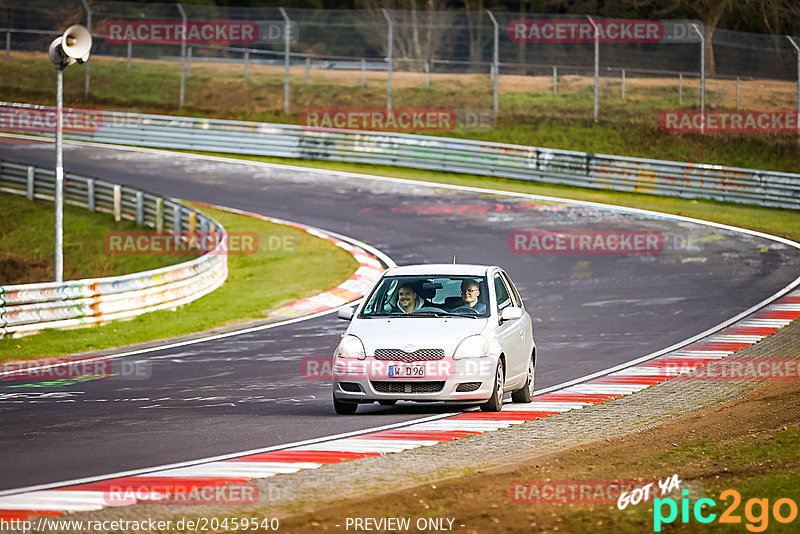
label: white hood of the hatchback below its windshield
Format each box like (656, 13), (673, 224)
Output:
(349, 317), (488, 356)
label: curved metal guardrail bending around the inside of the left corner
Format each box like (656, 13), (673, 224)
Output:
(0, 160), (228, 337)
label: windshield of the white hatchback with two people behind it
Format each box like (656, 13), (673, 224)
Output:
(359, 275), (489, 317)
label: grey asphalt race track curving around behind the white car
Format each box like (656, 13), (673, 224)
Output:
(0, 137), (800, 490)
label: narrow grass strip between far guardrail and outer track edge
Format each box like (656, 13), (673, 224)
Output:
(189, 154), (800, 241)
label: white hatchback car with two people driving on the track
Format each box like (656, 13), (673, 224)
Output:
(333, 264), (536, 414)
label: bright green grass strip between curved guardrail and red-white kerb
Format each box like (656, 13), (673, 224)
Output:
(0, 202), (358, 361)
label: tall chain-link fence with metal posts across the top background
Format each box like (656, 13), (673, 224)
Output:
(0, 0), (800, 129)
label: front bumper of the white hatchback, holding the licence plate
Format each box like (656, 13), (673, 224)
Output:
(333, 355), (498, 403)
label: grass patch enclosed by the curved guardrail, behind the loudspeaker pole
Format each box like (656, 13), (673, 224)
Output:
(0, 193), (195, 285)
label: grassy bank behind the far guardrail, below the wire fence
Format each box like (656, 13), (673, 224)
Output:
(0, 53), (800, 172)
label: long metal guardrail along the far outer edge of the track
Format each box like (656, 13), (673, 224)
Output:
(0, 102), (800, 209)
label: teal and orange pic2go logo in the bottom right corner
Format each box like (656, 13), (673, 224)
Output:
(653, 489), (797, 532)
